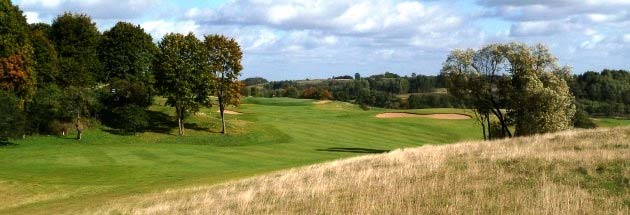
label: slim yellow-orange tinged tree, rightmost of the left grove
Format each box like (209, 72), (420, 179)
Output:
(204, 35), (243, 134)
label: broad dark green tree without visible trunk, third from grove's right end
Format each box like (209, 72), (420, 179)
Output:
(98, 22), (157, 132)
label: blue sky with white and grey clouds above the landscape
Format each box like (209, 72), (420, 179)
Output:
(14, 0), (630, 80)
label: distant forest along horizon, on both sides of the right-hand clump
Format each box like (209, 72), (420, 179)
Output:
(242, 69), (630, 117)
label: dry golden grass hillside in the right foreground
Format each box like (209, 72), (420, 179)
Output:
(99, 128), (630, 214)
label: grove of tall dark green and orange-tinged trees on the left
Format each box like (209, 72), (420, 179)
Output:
(0, 0), (243, 142)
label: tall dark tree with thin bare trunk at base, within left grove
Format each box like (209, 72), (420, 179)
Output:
(50, 13), (102, 140)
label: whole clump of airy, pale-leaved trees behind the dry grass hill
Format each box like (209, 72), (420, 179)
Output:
(442, 43), (576, 139)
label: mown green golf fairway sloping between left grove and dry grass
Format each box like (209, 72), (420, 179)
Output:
(0, 98), (480, 214)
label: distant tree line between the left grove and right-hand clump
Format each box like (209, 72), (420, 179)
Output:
(241, 72), (461, 109)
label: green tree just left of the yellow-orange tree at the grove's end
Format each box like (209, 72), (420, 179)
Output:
(154, 33), (212, 136)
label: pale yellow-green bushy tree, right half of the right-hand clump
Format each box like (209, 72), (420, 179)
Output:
(500, 43), (576, 136)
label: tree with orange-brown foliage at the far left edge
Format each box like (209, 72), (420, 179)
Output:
(0, 0), (36, 103)
